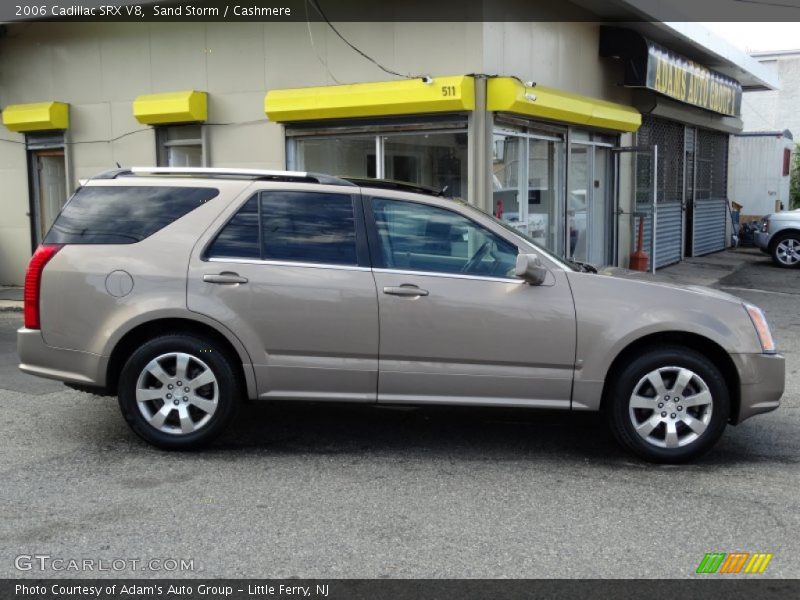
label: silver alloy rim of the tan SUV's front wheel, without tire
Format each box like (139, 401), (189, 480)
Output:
(628, 367), (713, 448)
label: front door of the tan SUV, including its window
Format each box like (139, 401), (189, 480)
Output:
(367, 198), (575, 408)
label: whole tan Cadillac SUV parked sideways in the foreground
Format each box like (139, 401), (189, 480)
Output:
(18, 168), (784, 462)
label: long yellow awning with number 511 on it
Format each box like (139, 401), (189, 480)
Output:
(264, 75), (475, 122)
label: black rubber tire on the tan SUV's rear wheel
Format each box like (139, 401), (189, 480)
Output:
(119, 333), (243, 450)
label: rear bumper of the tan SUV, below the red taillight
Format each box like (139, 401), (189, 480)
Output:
(17, 327), (108, 387)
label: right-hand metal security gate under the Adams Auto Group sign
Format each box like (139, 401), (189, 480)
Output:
(689, 129), (728, 256)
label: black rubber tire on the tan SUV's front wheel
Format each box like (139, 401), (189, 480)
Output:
(606, 346), (730, 464)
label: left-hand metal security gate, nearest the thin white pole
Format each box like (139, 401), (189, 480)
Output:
(634, 115), (684, 269)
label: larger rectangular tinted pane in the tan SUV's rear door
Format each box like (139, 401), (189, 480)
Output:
(261, 192), (357, 265)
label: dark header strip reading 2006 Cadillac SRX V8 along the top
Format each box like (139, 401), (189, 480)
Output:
(0, 0), (800, 22)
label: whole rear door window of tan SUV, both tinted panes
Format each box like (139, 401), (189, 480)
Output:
(206, 192), (358, 265)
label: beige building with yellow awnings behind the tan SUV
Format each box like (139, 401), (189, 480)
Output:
(0, 15), (774, 284)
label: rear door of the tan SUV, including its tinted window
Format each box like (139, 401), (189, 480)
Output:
(188, 184), (378, 402)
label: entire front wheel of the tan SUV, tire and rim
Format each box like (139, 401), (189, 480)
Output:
(606, 346), (730, 463)
